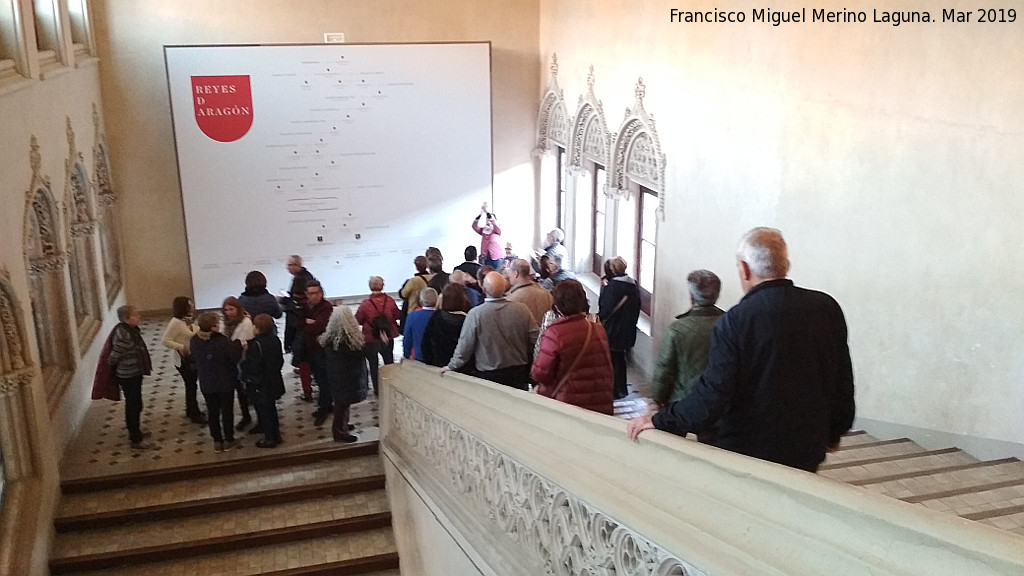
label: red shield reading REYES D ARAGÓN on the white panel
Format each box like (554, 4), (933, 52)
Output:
(191, 76), (253, 142)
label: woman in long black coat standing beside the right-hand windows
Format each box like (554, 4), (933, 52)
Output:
(597, 256), (640, 400)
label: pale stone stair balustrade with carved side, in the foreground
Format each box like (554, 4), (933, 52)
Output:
(380, 362), (1024, 576)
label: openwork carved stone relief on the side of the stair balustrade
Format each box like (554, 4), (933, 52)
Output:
(388, 390), (701, 576)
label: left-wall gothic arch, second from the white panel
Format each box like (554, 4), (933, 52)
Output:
(63, 117), (101, 344)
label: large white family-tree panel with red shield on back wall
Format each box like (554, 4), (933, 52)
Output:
(164, 43), (492, 308)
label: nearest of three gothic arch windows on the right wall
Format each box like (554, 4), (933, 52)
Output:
(608, 78), (665, 314)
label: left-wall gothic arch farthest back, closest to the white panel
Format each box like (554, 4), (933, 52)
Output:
(92, 104), (121, 306)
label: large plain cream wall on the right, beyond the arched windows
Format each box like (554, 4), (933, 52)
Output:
(541, 0), (1024, 443)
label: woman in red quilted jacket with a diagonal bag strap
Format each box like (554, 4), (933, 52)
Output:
(530, 280), (613, 414)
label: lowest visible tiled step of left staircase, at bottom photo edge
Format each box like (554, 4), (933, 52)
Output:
(54, 528), (398, 576)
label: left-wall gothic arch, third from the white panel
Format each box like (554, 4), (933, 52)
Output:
(25, 136), (75, 409)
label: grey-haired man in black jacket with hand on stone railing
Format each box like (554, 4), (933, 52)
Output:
(628, 228), (854, 471)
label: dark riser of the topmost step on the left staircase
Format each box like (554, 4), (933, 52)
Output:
(60, 441), (379, 494)
